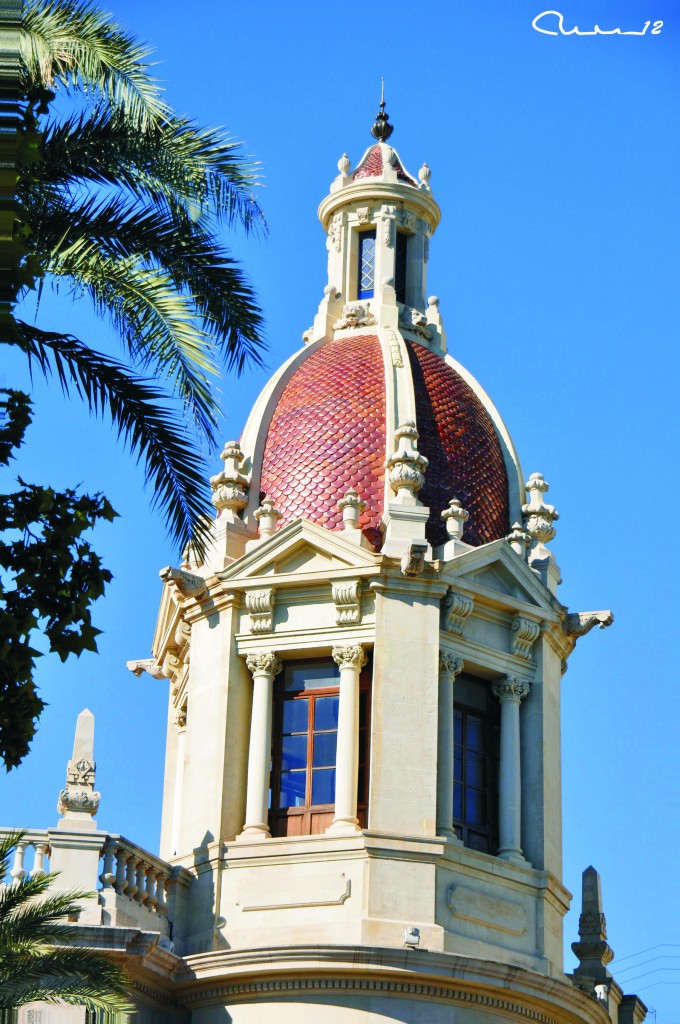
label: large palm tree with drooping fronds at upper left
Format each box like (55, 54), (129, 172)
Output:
(9, 0), (265, 545)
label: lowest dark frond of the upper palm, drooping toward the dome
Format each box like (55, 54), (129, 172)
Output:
(13, 322), (215, 554)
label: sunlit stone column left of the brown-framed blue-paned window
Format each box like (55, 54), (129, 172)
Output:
(239, 650), (283, 839)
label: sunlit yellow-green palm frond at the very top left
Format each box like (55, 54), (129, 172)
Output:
(22, 0), (169, 127)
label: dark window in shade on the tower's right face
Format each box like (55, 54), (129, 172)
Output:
(454, 676), (500, 853)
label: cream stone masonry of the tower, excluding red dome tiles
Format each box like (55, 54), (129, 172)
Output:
(1, 108), (644, 1024)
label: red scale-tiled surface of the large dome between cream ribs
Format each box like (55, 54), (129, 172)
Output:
(261, 335), (510, 547)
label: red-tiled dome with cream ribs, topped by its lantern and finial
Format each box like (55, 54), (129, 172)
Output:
(219, 104), (524, 558)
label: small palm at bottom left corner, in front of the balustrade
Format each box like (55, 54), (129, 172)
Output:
(0, 833), (134, 1015)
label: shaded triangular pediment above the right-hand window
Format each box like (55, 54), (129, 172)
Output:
(444, 540), (555, 608)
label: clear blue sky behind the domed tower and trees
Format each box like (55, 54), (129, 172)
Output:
(0, 0), (680, 1024)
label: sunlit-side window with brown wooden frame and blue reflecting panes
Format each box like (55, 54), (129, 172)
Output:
(270, 658), (371, 836)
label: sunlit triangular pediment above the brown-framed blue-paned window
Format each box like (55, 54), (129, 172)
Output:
(217, 519), (379, 582)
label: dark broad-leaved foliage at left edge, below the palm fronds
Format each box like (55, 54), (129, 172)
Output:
(0, 389), (116, 769)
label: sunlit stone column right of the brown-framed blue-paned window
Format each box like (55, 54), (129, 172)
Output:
(327, 644), (368, 831)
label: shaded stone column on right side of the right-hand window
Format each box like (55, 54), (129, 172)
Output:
(492, 676), (530, 863)
